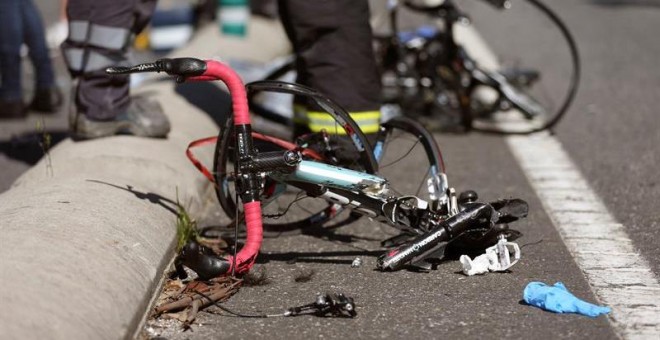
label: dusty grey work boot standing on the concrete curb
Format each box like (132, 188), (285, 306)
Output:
(71, 97), (170, 139)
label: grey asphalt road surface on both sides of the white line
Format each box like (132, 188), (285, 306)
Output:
(0, 0), (660, 339)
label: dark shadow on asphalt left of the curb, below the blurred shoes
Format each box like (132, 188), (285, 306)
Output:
(0, 130), (69, 165)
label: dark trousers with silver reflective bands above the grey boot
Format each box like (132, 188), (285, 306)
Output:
(62, 0), (157, 121)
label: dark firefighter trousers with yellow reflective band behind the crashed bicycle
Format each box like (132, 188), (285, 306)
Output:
(278, 0), (381, 135)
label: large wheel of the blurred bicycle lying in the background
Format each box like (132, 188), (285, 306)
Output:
(457, 0), (581, 134)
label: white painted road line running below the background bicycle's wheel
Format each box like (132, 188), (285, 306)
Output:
(506, 133), (660, 339)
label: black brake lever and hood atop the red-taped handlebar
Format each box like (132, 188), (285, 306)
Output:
(105, 58), (207, 80)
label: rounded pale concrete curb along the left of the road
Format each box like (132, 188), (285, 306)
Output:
(0, 19), (288, 339)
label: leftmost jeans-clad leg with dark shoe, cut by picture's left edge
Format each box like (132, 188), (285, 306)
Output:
(0, 0), (25, 118)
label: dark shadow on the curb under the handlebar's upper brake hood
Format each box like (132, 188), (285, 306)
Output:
(175, 82), (231, 126)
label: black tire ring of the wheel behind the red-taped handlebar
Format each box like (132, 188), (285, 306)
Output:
(213, 81), (378, 232)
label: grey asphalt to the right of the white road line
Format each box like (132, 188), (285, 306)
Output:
(467, 0), (660, 277)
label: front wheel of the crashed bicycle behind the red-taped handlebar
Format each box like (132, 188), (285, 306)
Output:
(214, 81), (377, 232)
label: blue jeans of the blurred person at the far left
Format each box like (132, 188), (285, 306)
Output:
(0, 0), (55, 101)
